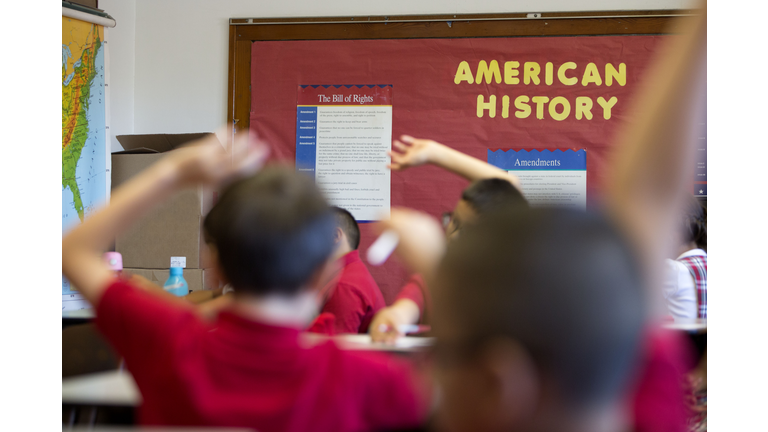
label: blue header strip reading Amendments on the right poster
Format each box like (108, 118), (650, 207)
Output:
(488, 149), (587, 171)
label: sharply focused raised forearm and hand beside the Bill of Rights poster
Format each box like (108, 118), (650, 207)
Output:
(389, 135), (520, 189)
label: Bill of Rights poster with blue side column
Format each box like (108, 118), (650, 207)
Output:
(296, 85), (392, 222)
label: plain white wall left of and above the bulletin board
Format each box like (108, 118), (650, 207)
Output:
(99, 0), (692, 151)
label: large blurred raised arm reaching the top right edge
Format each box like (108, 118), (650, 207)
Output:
(606, 7), (707, 282)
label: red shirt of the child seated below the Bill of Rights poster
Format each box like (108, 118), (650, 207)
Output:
(321, 250), (386, 334)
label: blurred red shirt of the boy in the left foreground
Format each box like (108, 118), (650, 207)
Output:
(96, 281), (426, 432)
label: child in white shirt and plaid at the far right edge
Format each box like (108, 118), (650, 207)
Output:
(664, 196), (707, 320)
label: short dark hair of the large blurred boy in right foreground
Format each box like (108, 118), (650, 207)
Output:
(433, 208), (645, 406)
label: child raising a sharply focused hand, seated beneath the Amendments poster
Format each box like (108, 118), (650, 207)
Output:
(369, 143), (528, 343)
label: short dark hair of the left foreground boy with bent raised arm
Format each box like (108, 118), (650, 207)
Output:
(204, 166), (335, 295)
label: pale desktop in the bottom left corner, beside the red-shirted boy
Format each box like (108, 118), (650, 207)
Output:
(61, 371), (141, 407)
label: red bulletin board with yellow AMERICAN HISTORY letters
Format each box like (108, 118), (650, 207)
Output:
(250, 35), (674, 303)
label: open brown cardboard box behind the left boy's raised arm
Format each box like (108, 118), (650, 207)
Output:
(112, 133), (215, 269)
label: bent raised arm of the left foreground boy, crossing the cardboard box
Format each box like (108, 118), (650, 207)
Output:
(61, 130), (268, 307)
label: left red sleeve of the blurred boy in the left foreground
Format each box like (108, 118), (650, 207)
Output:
(95, 280), (203, 381)
